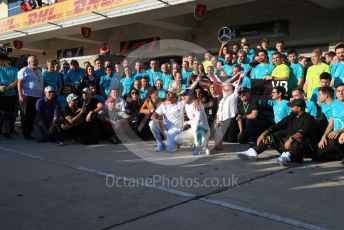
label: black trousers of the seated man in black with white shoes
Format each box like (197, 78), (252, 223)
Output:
(254, 130), (315, 162)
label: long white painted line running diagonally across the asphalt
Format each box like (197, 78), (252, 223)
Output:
(0, 147), (328, 230)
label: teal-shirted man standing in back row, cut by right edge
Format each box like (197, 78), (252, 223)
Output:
(331, 43), (344, 86)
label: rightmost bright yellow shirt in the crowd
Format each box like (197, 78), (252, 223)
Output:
(306, 63), (331, 99)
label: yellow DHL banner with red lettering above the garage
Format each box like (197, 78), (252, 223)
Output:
(0, 0), (143, 34)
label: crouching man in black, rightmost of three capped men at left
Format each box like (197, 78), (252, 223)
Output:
(79, 87), (104, 144)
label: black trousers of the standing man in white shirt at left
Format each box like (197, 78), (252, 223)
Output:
(22, 96), (39, 137)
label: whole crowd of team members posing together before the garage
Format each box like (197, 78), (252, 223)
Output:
(0, 38), (344, 165)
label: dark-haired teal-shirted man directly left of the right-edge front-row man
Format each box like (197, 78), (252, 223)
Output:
(319, 86), (334, 121)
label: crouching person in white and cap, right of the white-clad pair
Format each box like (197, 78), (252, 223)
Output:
(175, 89), (210, 155)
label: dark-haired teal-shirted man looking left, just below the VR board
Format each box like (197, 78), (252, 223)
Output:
(268, 86), (291, 123)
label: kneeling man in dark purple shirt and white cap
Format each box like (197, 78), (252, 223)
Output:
(33, 86), (63, 145)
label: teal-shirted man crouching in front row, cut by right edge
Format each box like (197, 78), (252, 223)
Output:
(316, 83), (344, 161)
